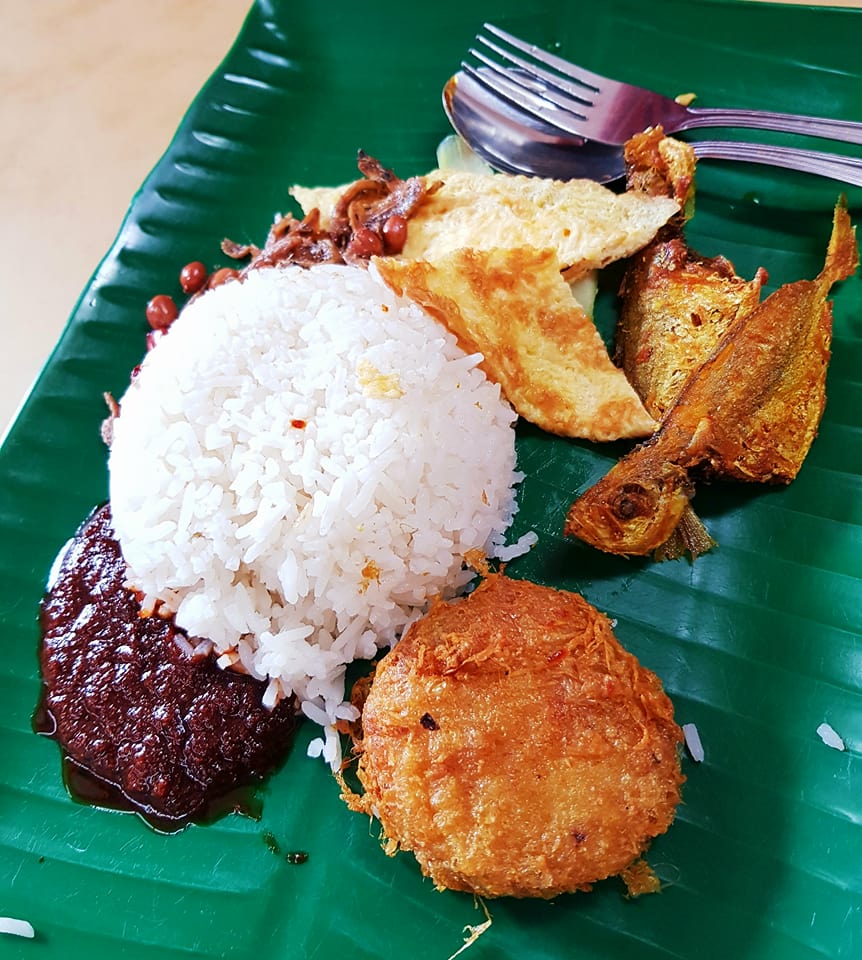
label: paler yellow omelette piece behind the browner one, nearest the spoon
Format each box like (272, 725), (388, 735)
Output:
(291, 170), (679, 280)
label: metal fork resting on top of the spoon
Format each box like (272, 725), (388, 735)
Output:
(470, 23), (862, 146)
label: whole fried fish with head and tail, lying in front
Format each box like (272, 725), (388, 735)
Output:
(565, 201), (858, 555)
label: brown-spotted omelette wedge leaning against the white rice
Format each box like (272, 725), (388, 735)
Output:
(375, 247), (656, 441)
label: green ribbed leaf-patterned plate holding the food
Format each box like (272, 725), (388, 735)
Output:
(0, 0), (862, 960)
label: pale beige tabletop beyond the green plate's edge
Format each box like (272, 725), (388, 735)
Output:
(0, 0), (862, 433)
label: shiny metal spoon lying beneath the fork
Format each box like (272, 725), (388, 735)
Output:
(443, 72), (862, 187)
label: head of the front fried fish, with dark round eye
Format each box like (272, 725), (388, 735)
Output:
(565, 456), (694, 556)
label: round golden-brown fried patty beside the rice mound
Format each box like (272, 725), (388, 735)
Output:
(344, 575), (684, 898)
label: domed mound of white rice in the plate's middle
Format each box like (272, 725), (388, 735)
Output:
(109, 265), (521, 765)
